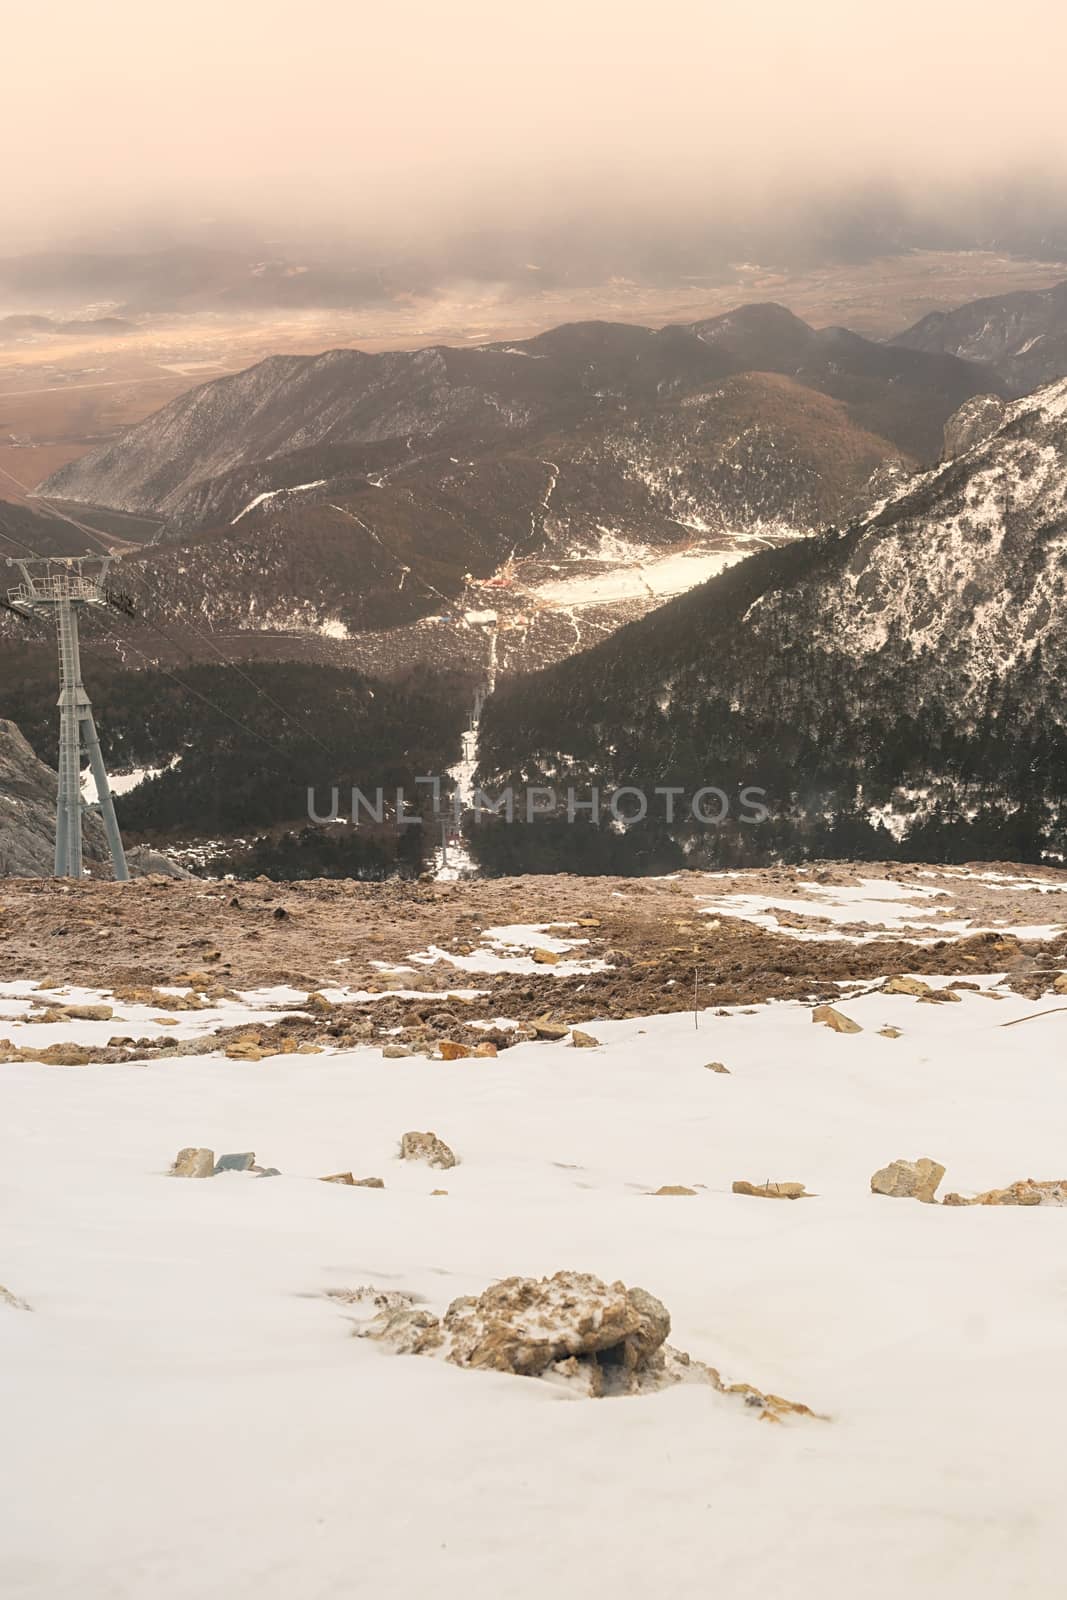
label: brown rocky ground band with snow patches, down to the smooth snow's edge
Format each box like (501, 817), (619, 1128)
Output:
(0, 864), (1067, 1059)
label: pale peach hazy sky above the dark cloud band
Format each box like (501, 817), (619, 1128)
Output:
(8, 0), (1067, 253)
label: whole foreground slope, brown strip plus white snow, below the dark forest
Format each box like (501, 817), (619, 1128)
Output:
(0, 864), (1067, 1600)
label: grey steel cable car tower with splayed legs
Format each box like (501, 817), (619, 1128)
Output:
(8, 555), (130, 883)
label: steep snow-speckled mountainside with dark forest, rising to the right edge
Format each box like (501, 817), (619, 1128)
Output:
(480, 382), (1067, 853)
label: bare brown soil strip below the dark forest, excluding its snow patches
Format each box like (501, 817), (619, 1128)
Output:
(0, 862), (1067, 1037)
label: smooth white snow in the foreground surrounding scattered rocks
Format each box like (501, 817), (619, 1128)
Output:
(0, 979), (1067, 1600)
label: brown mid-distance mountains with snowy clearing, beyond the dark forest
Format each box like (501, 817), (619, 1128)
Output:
(14, 304), (1001, 677)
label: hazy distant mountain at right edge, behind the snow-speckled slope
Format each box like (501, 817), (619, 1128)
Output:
(889, 282), (1067, 395)
